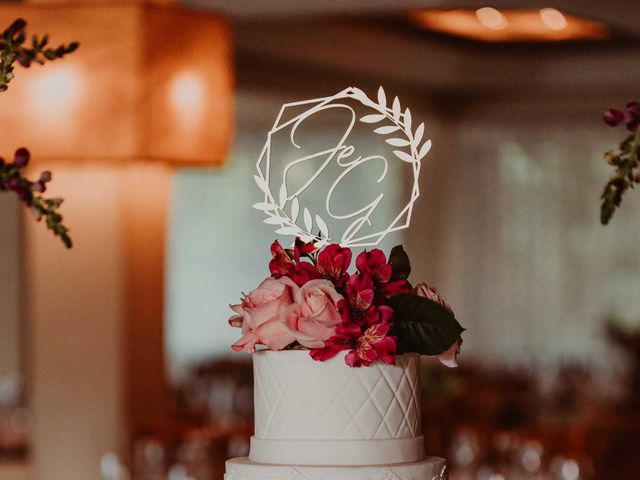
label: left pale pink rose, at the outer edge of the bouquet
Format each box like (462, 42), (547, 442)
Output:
(229, 277), (298, 353)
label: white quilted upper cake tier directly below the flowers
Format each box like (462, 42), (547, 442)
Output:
(253, 350), (421, 440)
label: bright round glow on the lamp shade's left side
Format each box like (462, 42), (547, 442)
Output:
(28, 65), (84, 123)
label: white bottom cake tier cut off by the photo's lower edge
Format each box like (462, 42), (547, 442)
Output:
(224, 457), (448, 480)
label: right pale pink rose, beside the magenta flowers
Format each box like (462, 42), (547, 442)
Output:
(282, 280), (342, 348)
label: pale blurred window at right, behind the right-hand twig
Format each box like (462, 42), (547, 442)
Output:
(451, 115), (640, 367)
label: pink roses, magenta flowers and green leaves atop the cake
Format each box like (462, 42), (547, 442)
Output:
(229, 238), (464, 367)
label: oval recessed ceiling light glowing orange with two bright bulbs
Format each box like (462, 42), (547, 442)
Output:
(410, 7), (610, 42)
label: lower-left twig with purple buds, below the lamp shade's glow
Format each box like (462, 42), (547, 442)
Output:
(0, 148), (73, 248)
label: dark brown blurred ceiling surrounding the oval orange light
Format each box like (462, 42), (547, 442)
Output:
(188, 0), (640, 102)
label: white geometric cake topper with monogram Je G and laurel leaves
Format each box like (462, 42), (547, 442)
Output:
(253, 87), (431, 248)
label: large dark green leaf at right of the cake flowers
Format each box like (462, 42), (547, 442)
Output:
(389, 294), (464, 355)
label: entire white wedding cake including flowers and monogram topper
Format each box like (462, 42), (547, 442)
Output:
(225, 87), (464, 480)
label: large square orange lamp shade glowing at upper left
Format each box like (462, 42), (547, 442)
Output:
(0, 3), (233, 165)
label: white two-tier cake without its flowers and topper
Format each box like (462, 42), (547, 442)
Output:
(225, 350), (447, 480)
